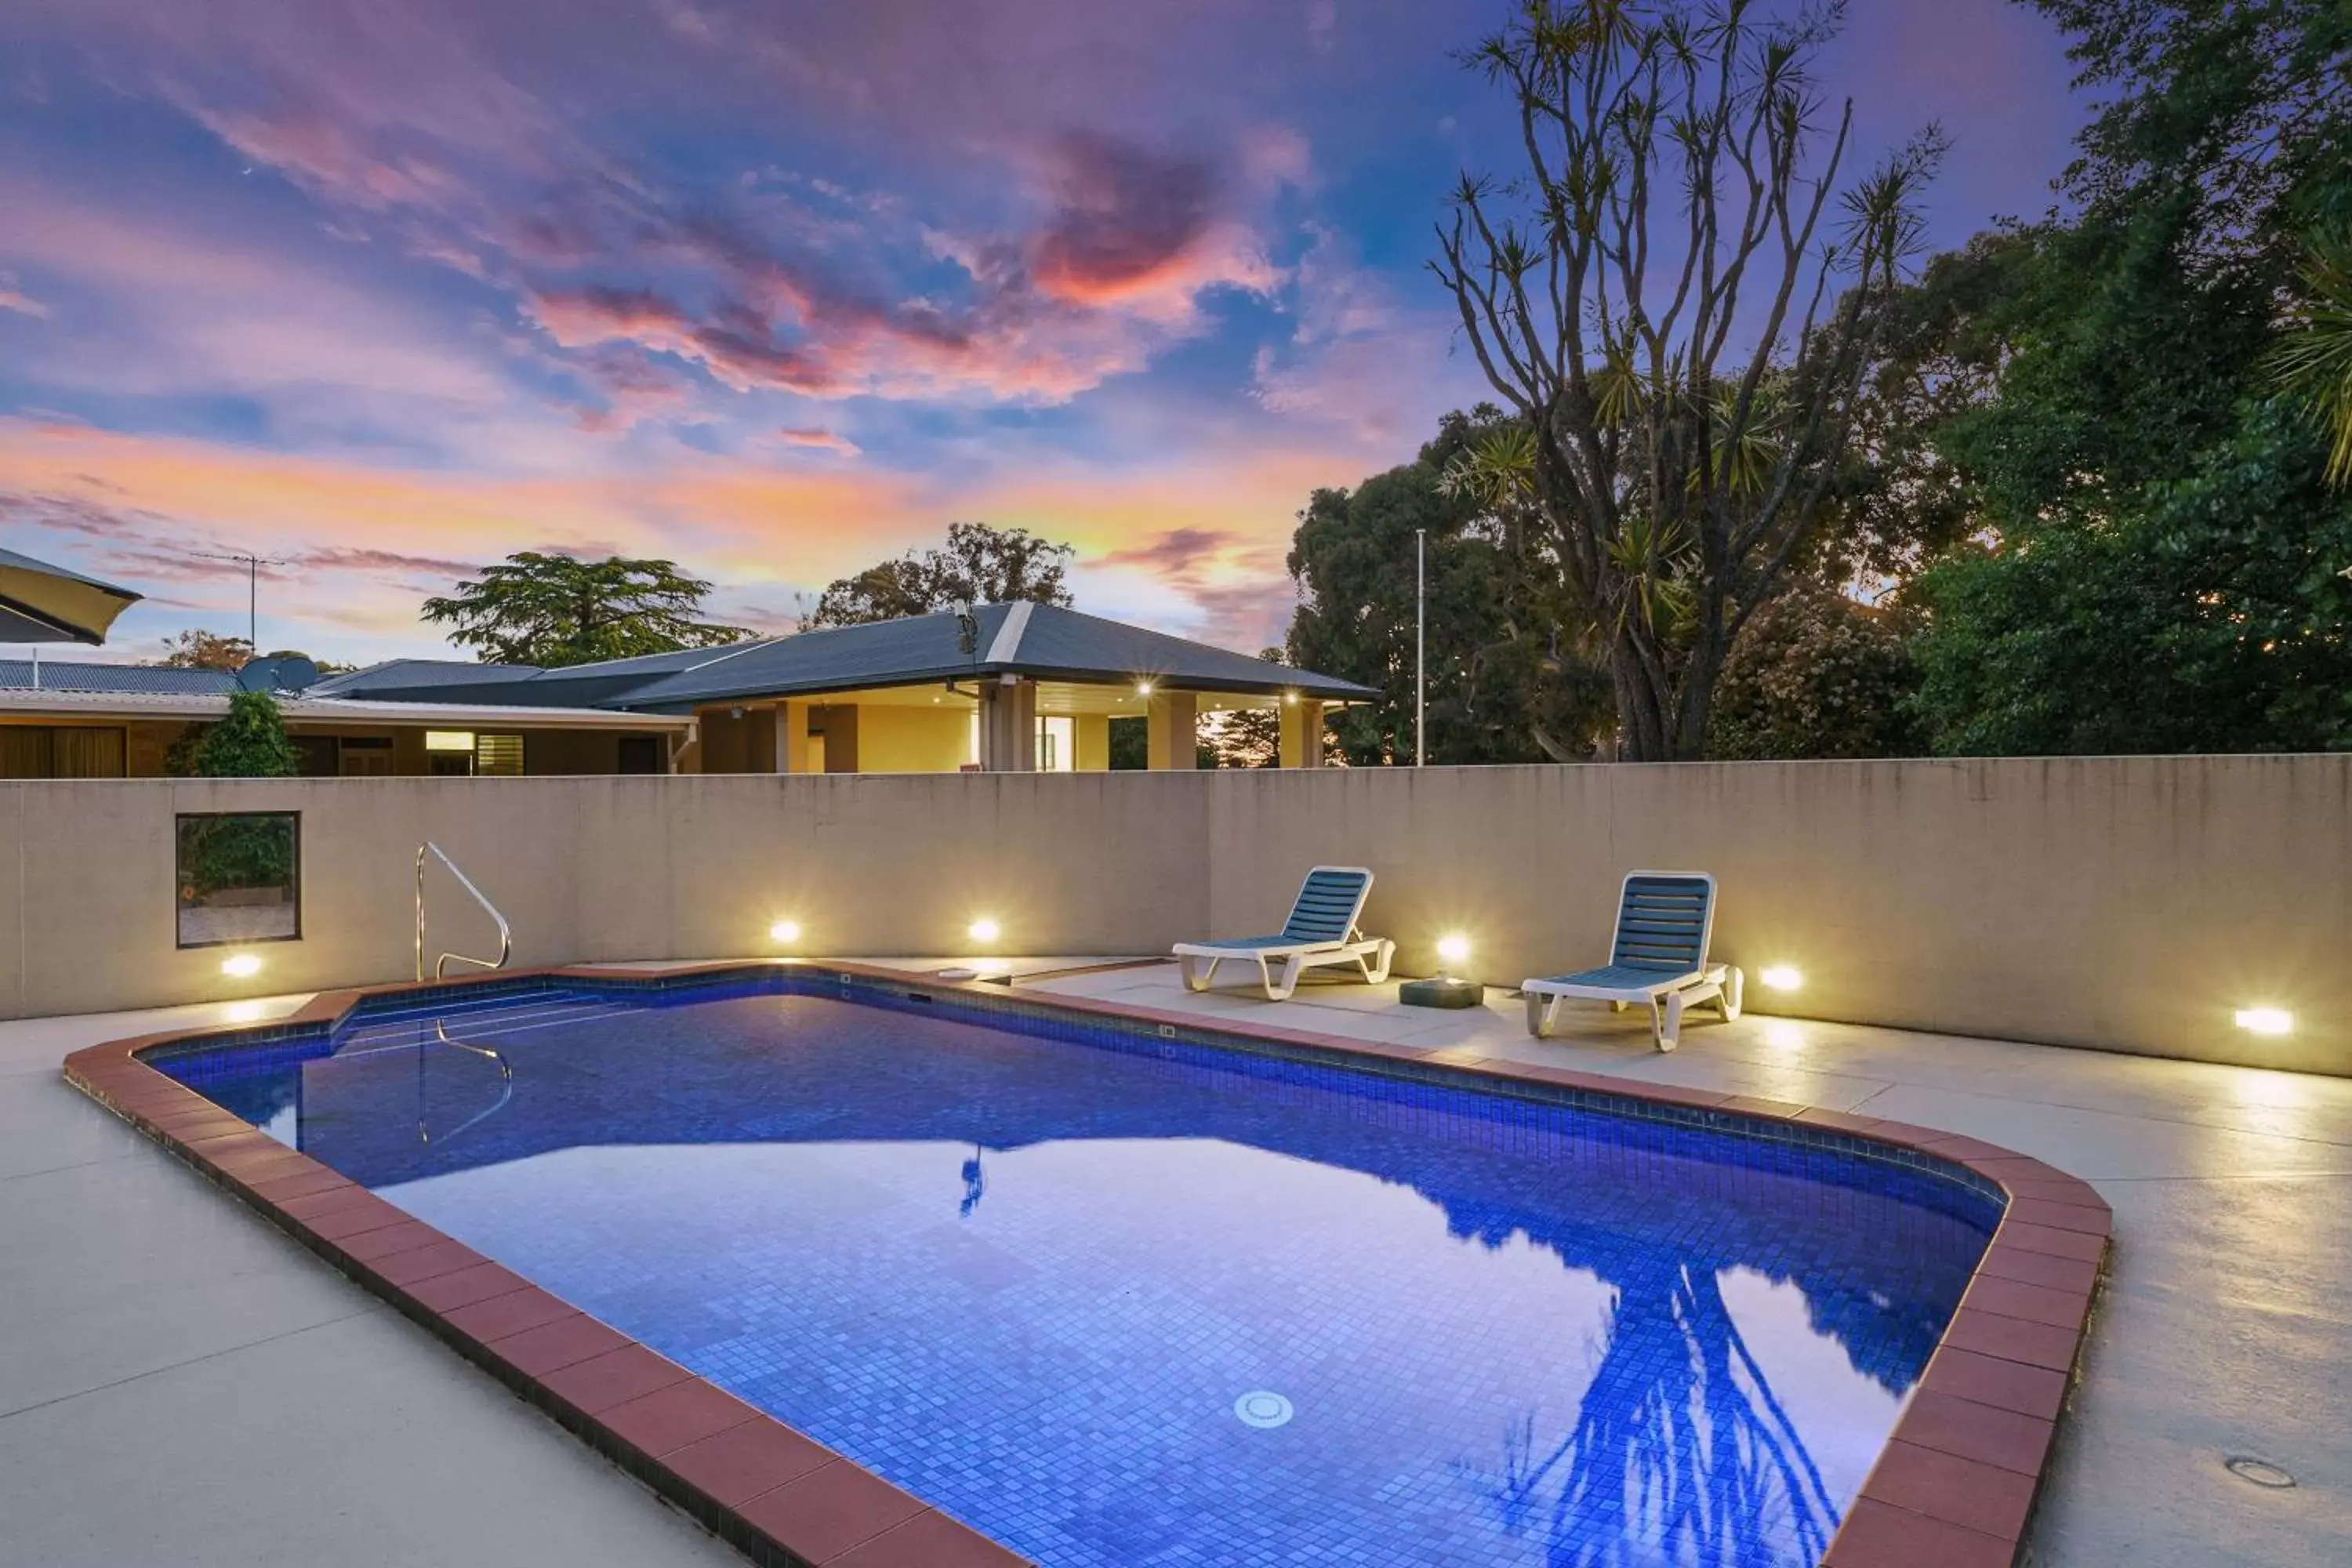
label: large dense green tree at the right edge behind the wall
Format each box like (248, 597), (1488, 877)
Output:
(1912, 0), (2352, 755)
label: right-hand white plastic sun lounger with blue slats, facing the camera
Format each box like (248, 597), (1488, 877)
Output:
(1519, 872), (1748, 1051)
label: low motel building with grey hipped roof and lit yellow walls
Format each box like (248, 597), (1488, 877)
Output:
(0, 602), (1378, 779)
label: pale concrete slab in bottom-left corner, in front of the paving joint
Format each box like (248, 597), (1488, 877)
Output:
(0, 1290), (743, 1568)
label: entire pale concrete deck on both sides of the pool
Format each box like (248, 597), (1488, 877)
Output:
(0, 961), (2352, 1566)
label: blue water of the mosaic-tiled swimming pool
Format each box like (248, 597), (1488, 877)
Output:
(170, 980), (1997, 1568)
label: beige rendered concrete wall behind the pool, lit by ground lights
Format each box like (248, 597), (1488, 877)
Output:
(0, 757), (2352, 1074)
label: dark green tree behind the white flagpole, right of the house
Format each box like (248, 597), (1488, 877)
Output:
(1287, 405), (1609, 767)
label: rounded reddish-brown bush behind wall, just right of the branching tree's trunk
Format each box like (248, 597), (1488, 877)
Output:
(1708, 588), (1922, 760)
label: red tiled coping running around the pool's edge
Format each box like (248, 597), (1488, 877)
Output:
(66, 964), (2112, 1568)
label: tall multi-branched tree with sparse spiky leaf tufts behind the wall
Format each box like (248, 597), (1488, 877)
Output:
(1432, 0), (1943, 760)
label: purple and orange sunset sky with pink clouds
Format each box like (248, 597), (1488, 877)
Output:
(0, 0), (2082, 661)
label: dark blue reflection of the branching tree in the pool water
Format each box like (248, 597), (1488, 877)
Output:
(1465, 1265), (1839, 1568)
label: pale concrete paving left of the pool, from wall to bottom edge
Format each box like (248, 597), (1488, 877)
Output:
(0, 996), (743, 1568)
